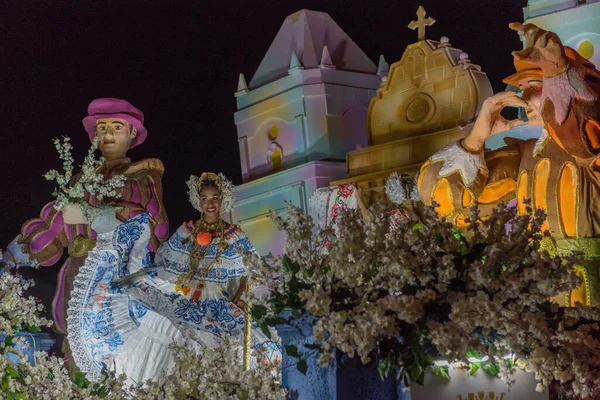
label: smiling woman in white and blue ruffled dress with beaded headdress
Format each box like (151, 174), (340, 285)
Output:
(119, 173), (281, 365)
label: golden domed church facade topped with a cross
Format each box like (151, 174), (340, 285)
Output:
(332, 7), (492, 203)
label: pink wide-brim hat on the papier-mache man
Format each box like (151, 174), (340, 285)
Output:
(82, 97), (148, 149)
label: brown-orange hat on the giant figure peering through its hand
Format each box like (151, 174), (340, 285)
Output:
(508, 22), (569, 76)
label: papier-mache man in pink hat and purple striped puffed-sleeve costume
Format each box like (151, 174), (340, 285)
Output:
(3, 98), (176, 382)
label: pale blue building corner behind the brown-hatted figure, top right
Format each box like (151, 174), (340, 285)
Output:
(523, 0), (600, 68)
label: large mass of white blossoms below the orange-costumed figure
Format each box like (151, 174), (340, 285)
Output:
(250, 204), (600, 398)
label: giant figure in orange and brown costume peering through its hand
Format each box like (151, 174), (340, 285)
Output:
(418, 23), (600, 305)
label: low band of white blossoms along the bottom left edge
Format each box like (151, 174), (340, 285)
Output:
(0, 340), (286, 400)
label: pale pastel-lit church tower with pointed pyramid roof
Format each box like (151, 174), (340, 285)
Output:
(230, 10), (385, 254)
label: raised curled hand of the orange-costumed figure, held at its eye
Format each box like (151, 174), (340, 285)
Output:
(462, 91), (527, 152)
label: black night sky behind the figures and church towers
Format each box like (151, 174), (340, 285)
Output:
(0, 0), (527, 316)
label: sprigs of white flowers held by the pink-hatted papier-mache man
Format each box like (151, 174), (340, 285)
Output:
(44, 137), (126, 220)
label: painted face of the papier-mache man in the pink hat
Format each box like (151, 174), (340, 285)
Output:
(96, 118), (137, 159)
